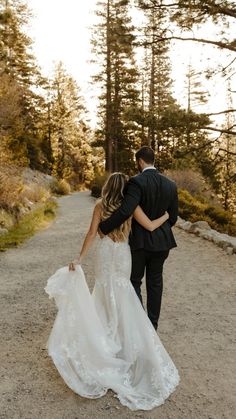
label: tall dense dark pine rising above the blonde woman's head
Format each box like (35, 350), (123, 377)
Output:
(94, 0), (139, 172)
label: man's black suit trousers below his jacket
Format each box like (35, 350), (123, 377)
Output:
(130, 249), (169, 329)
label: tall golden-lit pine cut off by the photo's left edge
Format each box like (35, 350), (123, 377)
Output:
(0, 0), (48, 168)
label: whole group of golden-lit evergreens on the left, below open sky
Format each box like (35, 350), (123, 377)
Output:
(0, 0), (93, 187)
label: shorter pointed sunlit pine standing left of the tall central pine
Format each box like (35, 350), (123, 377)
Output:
(48, 62), (93, 183)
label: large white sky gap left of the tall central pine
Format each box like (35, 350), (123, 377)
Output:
(28, 0), (97, 121)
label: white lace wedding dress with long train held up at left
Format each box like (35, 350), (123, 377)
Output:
(45, 236), (179, 410)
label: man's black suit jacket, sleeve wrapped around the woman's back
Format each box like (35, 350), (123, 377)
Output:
(99, 169), (178, 251)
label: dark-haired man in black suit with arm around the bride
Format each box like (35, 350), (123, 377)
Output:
(99, 146), (178, 329)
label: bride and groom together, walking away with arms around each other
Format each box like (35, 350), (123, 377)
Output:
(45, 147), (179, 410)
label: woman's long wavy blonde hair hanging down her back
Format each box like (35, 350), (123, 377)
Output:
(100, 172), (131, 241)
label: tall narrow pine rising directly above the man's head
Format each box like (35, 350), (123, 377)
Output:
(139, 0), (177, 168)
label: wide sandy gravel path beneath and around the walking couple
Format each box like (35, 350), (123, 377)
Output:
(0, 192), (236, 419)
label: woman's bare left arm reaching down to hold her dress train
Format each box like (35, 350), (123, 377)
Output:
(69, 204), (101, 270)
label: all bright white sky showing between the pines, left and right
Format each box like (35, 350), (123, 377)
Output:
(28, 0), (234, 126)
